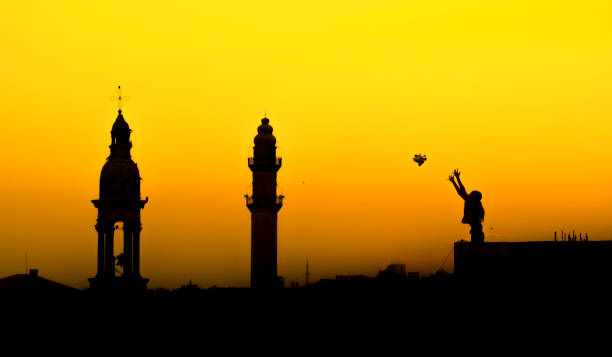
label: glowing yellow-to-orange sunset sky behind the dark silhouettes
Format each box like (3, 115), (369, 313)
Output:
(0, 0), (612, 288)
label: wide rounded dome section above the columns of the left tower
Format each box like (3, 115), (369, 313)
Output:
(100, 158), (140, 199)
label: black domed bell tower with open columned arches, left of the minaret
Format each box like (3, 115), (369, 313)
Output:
(89, 109), (149, 290)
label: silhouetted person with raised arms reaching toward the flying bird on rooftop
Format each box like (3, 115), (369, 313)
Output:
(448, 169), (484, 243)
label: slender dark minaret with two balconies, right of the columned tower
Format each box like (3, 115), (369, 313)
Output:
(245, 118), (283, 288)
